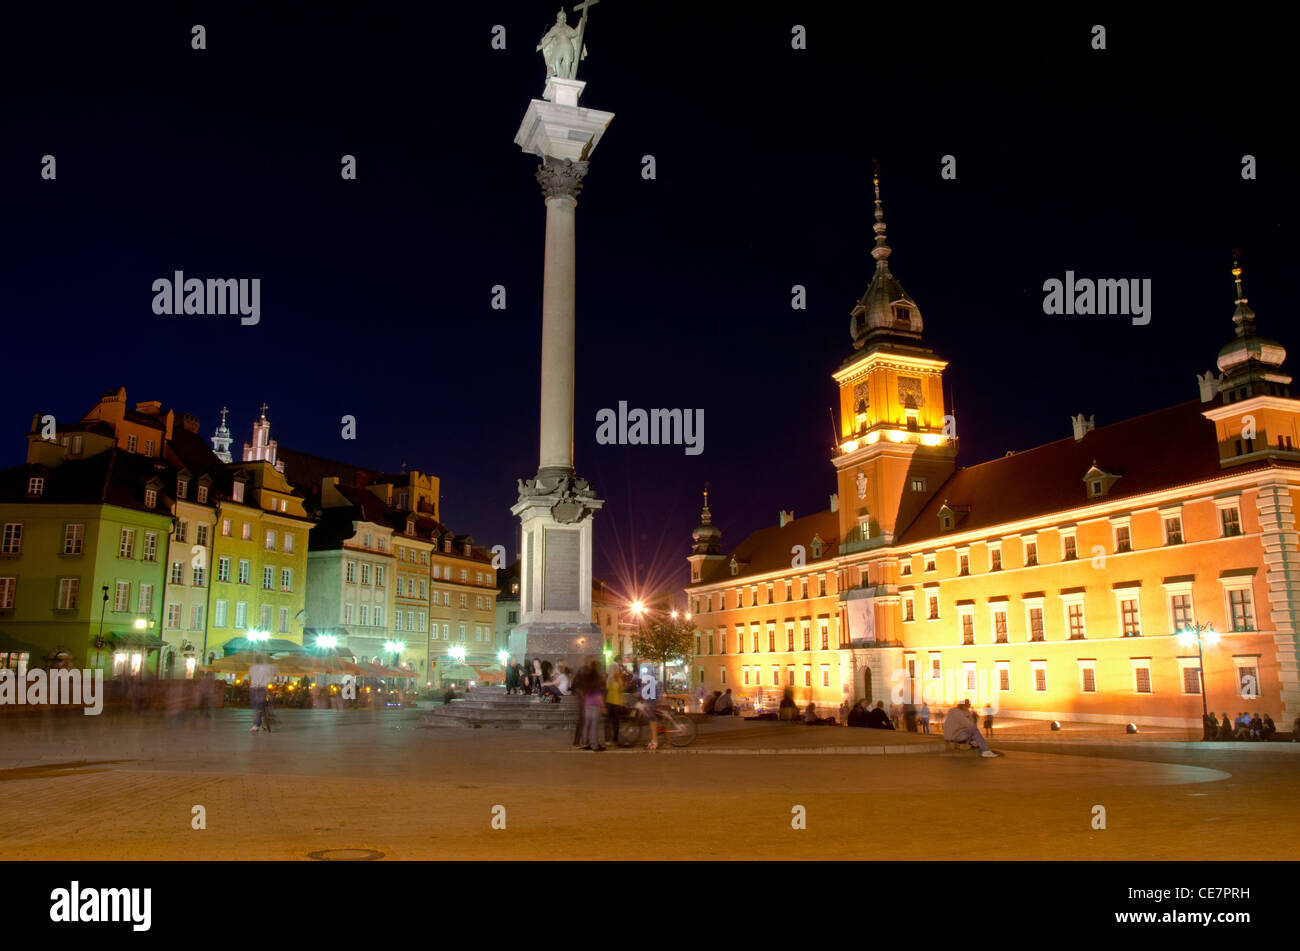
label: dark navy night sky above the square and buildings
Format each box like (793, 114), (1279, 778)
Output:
(0, 0), (1300, 602)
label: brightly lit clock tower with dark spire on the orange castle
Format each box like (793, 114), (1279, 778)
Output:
(832, 171), (957, 553)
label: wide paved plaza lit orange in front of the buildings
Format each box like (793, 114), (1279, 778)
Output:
(0, 709), (1300, 860)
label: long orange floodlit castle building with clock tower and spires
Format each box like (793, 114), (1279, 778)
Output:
(686, 183), (1300, 729)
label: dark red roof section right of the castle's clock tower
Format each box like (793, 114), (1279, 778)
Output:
(898, 400), (1269, 546)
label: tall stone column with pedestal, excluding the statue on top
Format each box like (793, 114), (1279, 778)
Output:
(508, 75), (614, 668)
